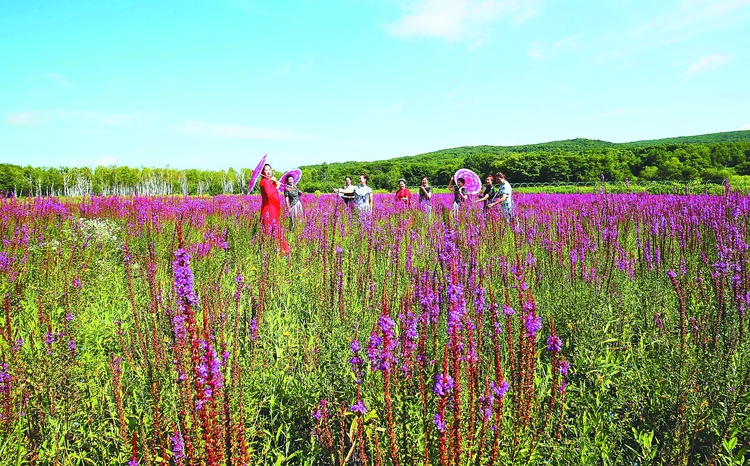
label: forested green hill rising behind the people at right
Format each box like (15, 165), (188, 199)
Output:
(301, 131), (750, 191)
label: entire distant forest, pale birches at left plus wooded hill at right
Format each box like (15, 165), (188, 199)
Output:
(0, 131), (750, 196)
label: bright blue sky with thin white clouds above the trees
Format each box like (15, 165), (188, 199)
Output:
(0, 0), (750, 170)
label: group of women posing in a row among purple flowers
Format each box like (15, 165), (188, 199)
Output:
(260, 164), (513, 254)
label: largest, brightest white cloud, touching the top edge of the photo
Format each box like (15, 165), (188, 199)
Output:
(389, 0), (539, 43)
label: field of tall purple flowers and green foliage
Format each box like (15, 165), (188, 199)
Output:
(0, 191), (750, 465)
